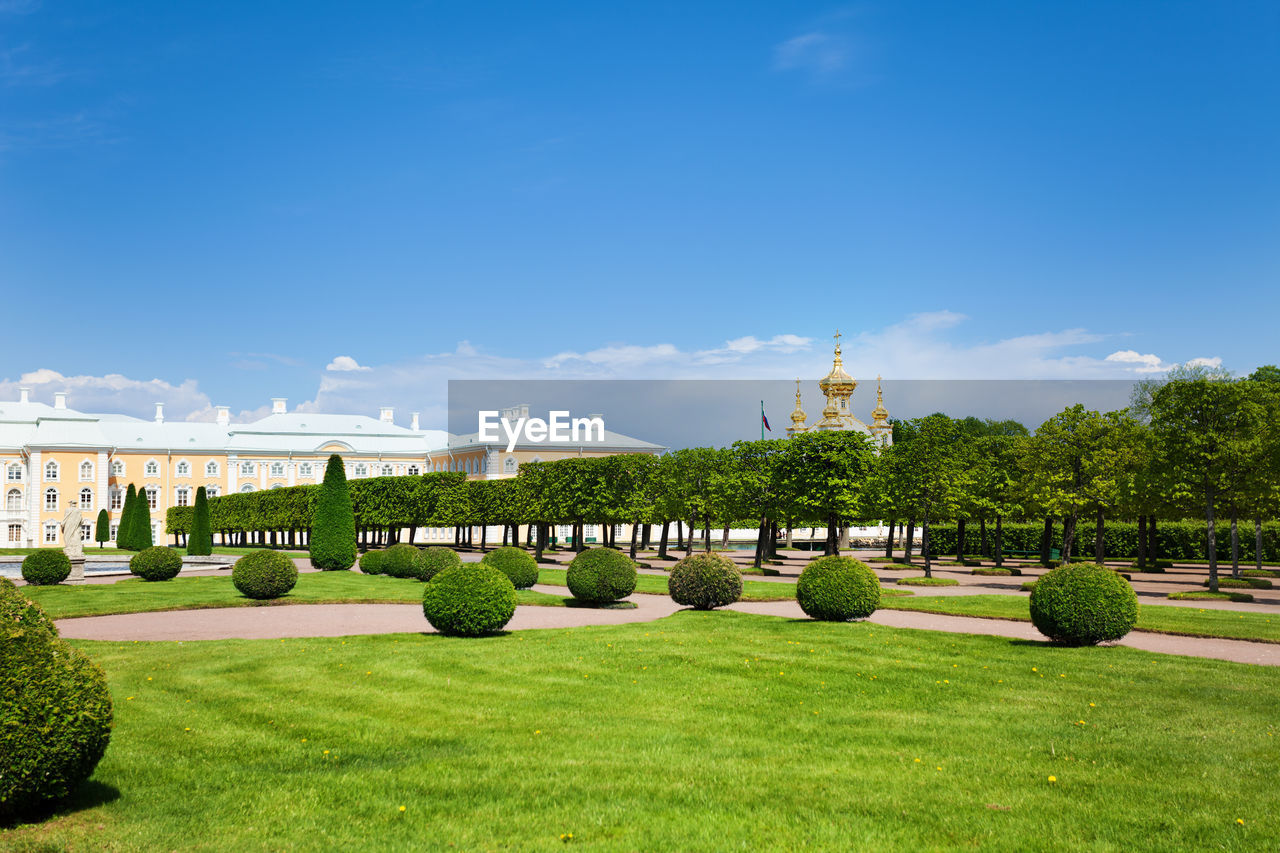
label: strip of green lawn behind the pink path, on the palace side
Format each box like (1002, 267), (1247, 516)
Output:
(22, 571), (564, 619)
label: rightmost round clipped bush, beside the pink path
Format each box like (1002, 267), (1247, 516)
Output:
(1030, 562), (1138, 646)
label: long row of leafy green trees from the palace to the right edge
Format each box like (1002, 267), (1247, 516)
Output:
(167, 368), (1280, 588)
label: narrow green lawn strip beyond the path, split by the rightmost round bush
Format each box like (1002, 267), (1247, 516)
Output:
(881, 596), (1280, 643)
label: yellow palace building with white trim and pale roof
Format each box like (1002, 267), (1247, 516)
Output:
(0, 389), (664, 548)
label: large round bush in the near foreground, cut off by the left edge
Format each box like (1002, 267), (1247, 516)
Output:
(0, 578), (111, 824)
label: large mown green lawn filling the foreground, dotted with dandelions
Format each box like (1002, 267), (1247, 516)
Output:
(0, 611), (1280, 853)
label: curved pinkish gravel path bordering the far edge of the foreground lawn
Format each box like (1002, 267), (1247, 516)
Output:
(58, 585), (1280, 666)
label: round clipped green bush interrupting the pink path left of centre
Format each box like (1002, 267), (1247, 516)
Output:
(422, 562), (516, 637)
